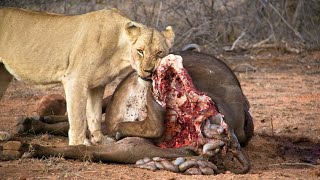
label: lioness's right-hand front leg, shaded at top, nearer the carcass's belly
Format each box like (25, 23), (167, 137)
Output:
(87, 87), (105, 144)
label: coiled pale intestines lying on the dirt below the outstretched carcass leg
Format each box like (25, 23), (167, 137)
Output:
(136, 157), (218, 175)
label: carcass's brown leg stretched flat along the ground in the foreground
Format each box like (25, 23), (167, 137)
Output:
(3, 137), (195, 164)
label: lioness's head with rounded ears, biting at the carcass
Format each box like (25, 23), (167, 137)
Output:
(126, 22), (174, 79)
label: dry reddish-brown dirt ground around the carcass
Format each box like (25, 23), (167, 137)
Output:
(0, 52), (320, 179)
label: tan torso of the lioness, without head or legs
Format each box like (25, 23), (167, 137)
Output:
(0, 9), (130, 86)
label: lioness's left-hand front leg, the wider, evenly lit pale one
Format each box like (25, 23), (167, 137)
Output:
(63, 79), (88, 145)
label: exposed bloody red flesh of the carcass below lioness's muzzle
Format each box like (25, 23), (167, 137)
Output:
(152, 55), (219, 148)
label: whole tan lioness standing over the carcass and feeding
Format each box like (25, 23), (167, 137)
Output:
(0, 8), (174, 145)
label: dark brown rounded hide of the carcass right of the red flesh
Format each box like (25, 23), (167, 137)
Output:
(177, 51), (254, 146)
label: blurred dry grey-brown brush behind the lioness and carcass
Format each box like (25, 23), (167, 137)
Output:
(0, 0), (320, 54)
